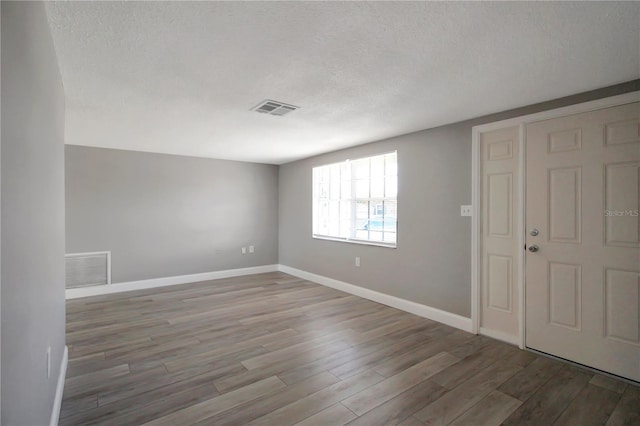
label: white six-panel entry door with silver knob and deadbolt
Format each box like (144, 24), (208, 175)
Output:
(525, 102), (640, 381)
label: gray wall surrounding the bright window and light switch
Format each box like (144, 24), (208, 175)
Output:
(279, 80), (640, 317)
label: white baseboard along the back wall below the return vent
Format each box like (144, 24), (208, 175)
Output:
(65, 264), (278, 299)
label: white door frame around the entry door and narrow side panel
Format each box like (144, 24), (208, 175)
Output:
(471, 91), (640, 349)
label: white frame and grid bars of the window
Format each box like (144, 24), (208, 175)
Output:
(311, 151), (398, 248)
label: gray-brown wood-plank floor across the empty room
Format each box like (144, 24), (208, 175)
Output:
(60, 273), (640, 426)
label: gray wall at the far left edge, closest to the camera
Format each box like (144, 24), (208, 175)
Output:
(1, 2), (65, 425)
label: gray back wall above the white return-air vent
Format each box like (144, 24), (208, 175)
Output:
(65, 145), (278, 283)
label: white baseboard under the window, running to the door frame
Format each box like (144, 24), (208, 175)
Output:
(278, 265), (471, 333)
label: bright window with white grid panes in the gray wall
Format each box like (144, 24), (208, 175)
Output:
(313, 152), (398, 247)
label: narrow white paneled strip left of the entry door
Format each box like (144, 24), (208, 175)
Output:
(480, 126), (522, 343)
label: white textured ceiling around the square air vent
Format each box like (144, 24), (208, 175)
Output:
(47, 2), (640, 164)
